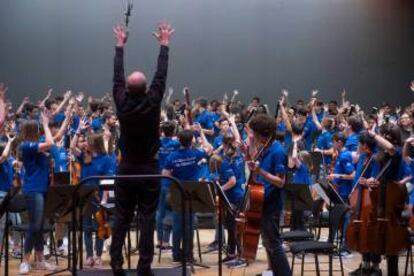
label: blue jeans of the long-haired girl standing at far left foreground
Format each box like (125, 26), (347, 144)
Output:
(24, 192), (45, 254)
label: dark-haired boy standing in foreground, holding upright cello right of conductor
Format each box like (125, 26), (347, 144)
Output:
(248, 115), (292, 276)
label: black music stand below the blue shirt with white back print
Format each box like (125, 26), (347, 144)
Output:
(170, 181), (215, 272)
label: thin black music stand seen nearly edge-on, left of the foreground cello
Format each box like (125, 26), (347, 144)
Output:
(207, 181), (236, 276)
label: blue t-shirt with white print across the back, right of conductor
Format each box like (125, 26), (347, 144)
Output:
(164, 148), (208, 181)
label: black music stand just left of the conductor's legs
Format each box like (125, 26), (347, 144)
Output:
(44, 185), (95, 276)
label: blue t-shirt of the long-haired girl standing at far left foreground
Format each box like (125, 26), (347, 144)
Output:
(20, 141), (49, 193)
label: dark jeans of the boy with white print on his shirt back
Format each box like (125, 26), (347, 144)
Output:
(172, 212), (195, 259)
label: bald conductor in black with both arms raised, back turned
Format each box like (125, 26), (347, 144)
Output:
(111, 24), (174, 276)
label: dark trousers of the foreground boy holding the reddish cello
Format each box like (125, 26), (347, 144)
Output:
(261, 210), (292, 276)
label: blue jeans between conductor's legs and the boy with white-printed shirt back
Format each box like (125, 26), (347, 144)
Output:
(157, 187), (172, 243)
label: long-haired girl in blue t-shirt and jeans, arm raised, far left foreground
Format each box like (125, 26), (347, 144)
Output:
(20, 113), (55, 274)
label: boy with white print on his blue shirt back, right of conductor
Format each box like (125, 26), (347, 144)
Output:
(162, 127), (211, 262)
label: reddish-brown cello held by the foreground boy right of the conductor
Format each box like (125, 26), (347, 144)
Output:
(236, 137), (273, 262)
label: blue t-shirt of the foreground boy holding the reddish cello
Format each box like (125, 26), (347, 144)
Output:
(257, 141), (287, 212)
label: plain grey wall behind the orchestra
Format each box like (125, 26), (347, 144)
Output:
(0, 0), (414, 109)
